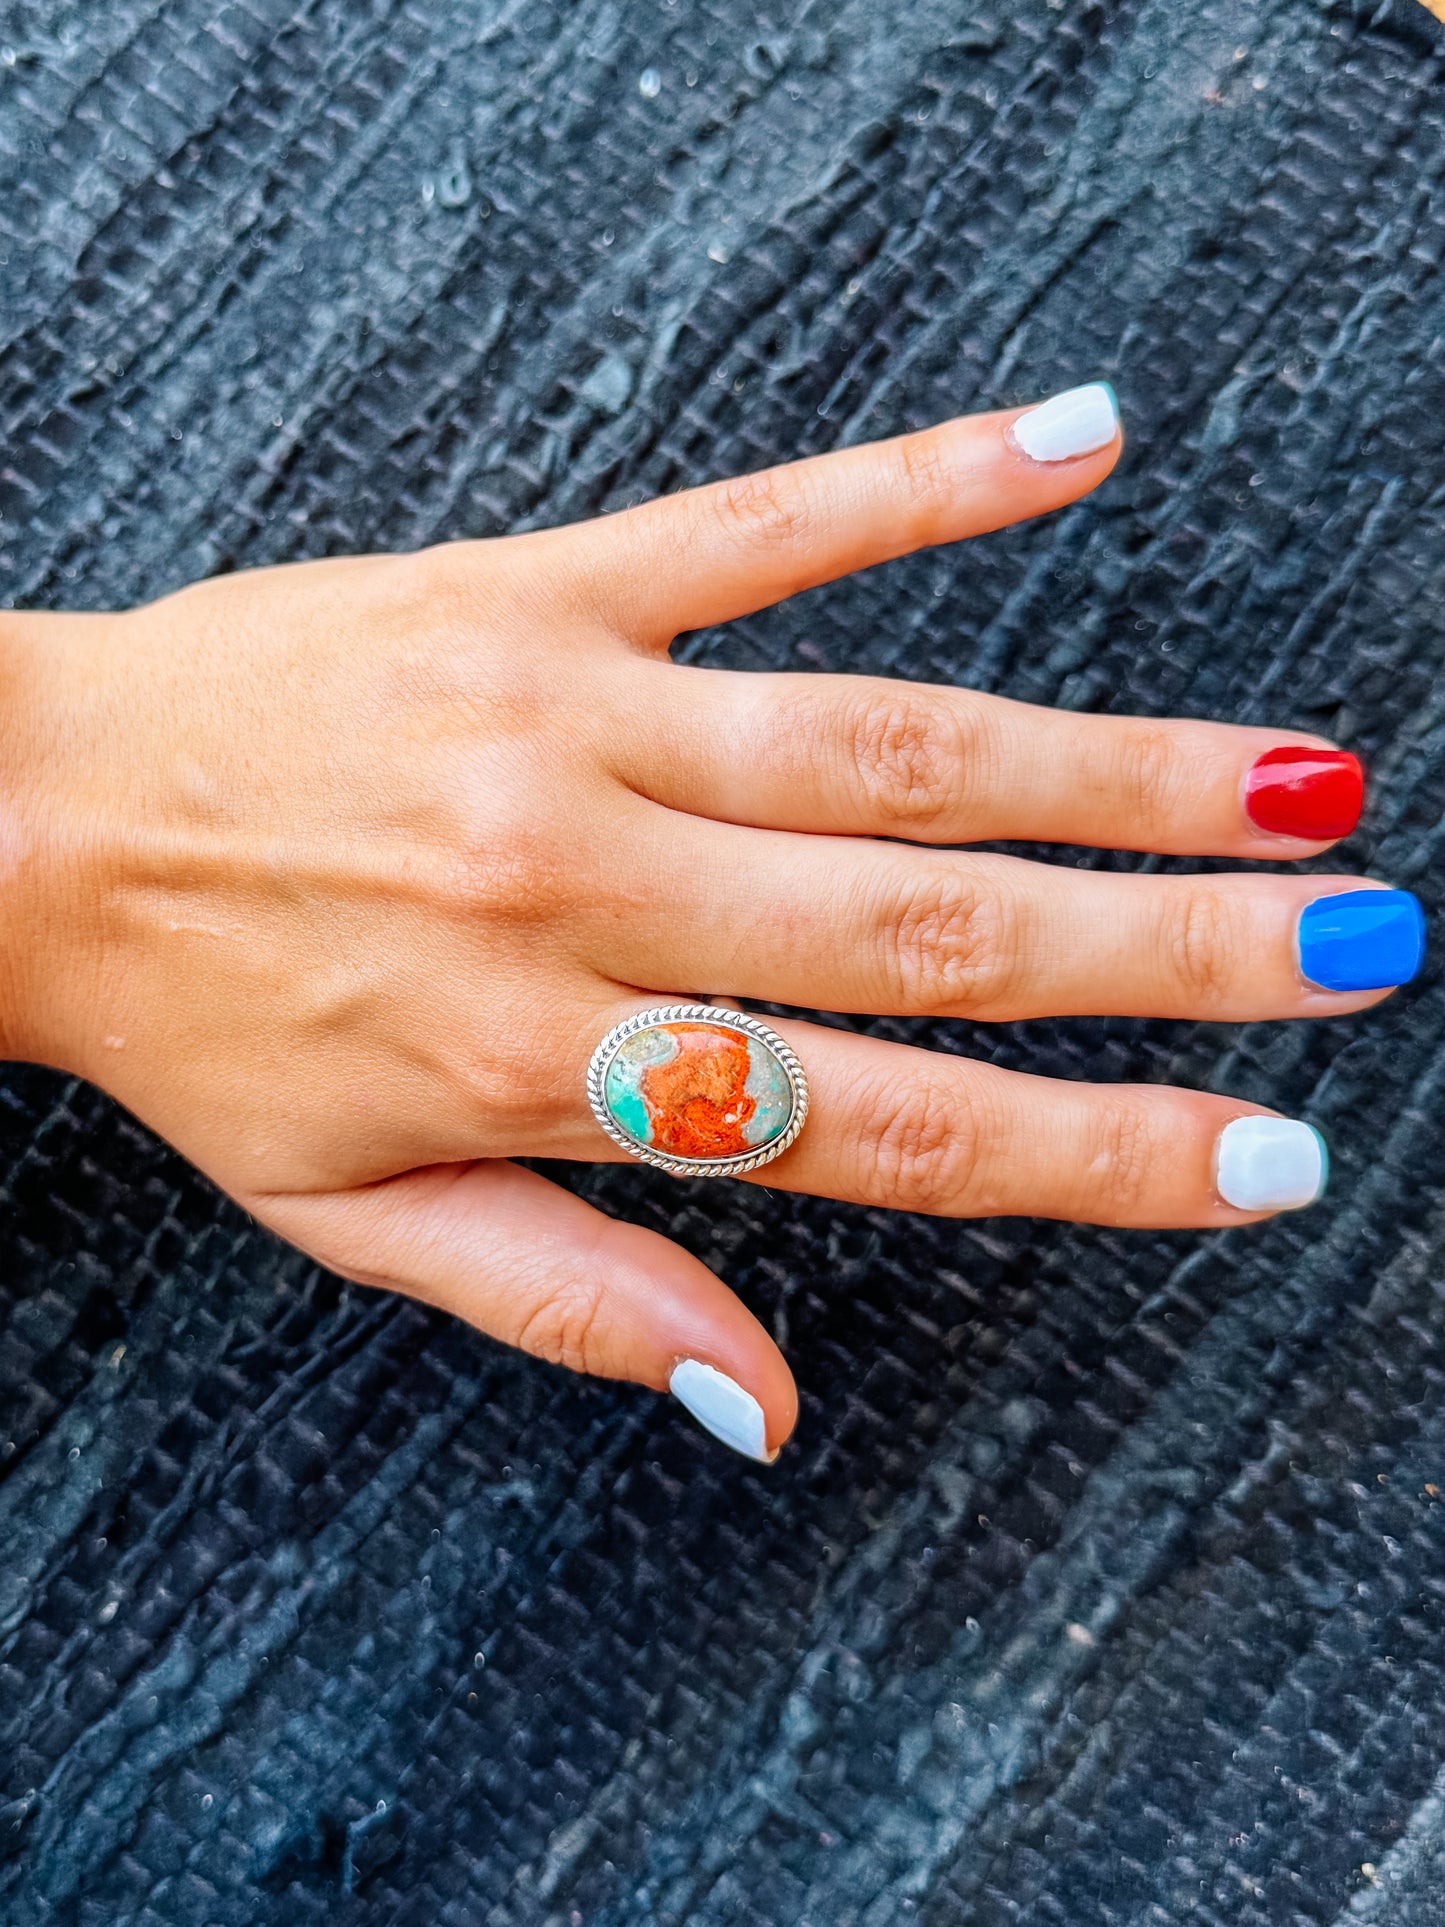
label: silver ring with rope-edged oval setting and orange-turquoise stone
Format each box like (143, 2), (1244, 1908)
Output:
(588, 1004), (807, 1177)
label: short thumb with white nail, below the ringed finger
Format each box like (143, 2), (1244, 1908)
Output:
(260, 1160), (798, 1461)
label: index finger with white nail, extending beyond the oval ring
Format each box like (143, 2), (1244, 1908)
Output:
(749, 1023), (1327, 1227)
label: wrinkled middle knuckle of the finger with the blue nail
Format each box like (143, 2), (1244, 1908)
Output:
(884, 873), (1013, 1014)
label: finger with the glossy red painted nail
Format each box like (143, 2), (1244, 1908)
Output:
(613, 661), (1364, 858)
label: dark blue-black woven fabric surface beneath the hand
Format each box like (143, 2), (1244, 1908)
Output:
(0, 0), (1445, 1927)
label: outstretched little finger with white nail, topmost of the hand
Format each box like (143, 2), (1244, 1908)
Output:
(570, 382), (1121, 647)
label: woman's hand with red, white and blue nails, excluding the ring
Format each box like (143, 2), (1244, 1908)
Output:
(0, 389), (1418, 1457)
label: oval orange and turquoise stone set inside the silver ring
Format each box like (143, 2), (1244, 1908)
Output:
(603, 1019), (794, 1162)
